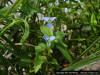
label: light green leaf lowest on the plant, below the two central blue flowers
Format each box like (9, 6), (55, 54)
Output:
(34, 56), (46, 73)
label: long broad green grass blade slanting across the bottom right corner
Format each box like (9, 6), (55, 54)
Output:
(63, 55), (100, 71)
